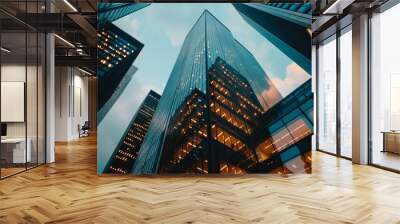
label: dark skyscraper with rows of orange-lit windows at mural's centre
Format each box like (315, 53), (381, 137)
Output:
(159, 57), (263, 174)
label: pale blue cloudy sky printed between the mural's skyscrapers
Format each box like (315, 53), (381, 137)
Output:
(98, 3), (310, 171)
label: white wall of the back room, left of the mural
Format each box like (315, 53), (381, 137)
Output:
(55, 67), (88, 141)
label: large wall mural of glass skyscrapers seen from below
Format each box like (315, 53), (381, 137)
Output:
(97, 3), (313, 175)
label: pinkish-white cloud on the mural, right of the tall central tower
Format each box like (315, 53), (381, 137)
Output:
(270, 63), (311, 97)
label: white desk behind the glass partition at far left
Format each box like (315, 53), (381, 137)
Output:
(1, 138), (32, 163)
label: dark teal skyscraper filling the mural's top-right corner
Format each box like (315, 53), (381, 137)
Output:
(233, 3), (312, 74)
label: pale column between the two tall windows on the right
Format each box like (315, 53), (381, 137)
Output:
(352, 15), (368, 164)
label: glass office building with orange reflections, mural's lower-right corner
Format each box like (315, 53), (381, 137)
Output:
(250, 80), (314, 173)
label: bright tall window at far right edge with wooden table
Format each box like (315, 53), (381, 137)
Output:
(370, 4), (400, 170)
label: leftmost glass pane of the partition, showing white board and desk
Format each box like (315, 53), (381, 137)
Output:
(0, 32), (27, 177)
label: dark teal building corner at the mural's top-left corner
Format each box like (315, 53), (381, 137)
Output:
(97, 2), (150, 28)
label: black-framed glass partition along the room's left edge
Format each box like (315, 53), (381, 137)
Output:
(0, 1), (46, 179)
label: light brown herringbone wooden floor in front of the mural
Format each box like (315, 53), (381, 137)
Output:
(0, 138), (400, 224)
